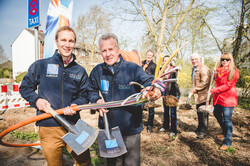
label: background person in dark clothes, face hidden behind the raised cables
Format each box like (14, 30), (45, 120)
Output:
(160, 55), (180, 136)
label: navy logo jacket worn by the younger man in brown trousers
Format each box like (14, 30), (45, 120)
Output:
(19, 51), (89, 126)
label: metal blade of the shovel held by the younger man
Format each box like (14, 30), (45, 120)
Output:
(62, 119), (99, 155)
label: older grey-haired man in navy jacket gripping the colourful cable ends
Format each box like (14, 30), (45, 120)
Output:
(89, 33), (161, 166)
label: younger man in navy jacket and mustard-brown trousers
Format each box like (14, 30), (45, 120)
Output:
(20, 26), (91, 166)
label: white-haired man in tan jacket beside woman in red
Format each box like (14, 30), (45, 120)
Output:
(189, 53), (211, 139)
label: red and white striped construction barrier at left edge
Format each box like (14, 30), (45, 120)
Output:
(0, 83), (29, 110)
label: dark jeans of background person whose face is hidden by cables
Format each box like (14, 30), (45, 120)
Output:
(163, 101), (177, 133)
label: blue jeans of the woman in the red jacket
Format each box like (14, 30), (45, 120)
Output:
(214, 105), (234, 146)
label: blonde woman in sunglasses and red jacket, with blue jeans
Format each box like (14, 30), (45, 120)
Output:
(210, 53), (239, 150)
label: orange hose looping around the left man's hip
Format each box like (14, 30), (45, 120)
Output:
(0, 106), (79, 147)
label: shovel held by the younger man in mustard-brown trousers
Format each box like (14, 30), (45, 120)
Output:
(48, 108), (99, 155)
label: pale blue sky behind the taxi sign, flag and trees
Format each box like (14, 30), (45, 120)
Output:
(0, 0), (234, 62)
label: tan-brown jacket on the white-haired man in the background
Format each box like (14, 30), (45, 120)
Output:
(192, 63), (211, 104)
